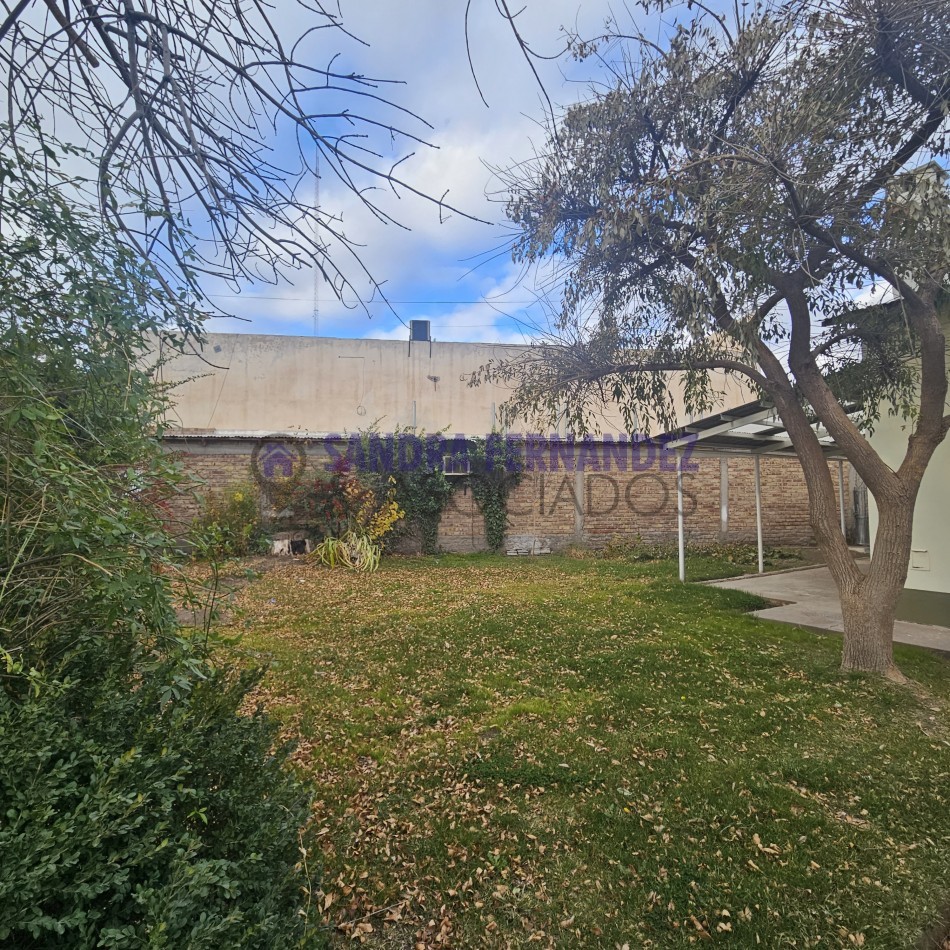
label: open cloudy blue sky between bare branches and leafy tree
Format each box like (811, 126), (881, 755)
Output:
(208, 0), (610, 343)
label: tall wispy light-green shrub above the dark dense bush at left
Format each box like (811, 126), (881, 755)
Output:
(0, 149), (198, 670)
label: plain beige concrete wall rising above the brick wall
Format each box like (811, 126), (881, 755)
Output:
(156, 333), (755, 435)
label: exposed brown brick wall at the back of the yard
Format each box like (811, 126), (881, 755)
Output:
(160, 438), (851, 552)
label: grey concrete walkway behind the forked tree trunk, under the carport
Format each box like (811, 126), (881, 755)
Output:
(707, 561), (950, 653)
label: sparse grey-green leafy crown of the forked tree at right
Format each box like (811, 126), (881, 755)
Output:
(483, 0), (950, 432)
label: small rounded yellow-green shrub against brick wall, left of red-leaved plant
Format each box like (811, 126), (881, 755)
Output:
(190, 484), (270, 559)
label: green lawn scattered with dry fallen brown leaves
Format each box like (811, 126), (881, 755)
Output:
(218, 556), (950, 950)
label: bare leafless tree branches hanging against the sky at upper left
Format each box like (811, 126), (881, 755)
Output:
(0, 0), (480, 316)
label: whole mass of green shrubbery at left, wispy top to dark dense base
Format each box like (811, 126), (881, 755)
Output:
(0, 147), (322, 948)
